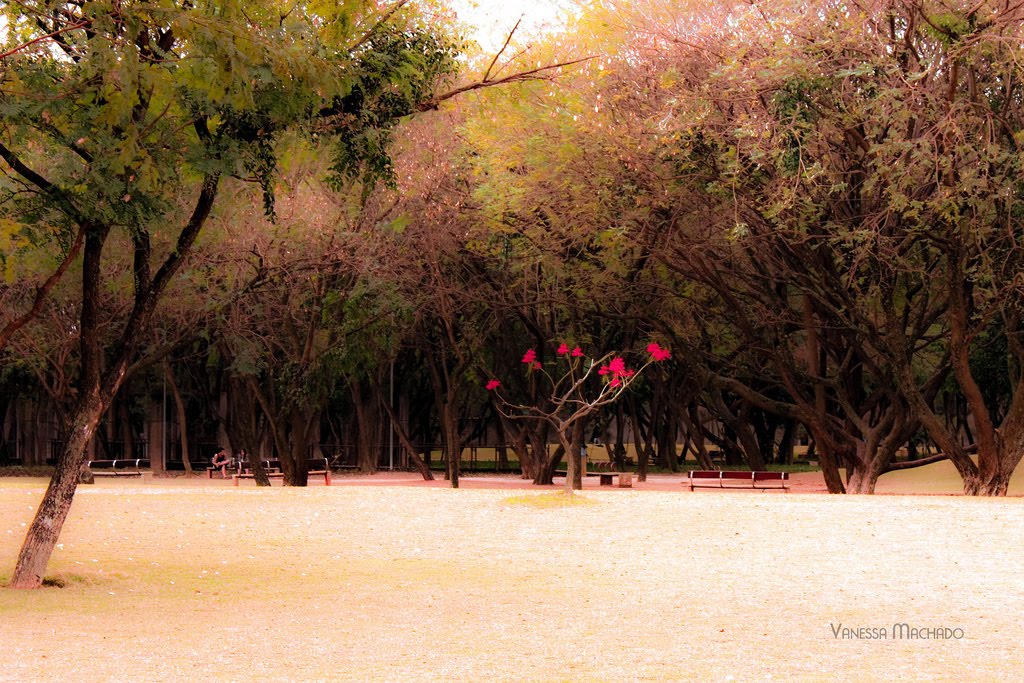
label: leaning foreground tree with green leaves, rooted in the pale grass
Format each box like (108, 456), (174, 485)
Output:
(0, 1), (454, 588)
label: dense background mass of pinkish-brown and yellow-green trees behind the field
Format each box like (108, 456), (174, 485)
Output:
(6, 0), (1024, 495)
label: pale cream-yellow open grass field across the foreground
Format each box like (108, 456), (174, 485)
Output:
(0, 477), (1024, 682)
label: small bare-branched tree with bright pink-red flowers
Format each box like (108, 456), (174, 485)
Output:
(485, 342), (672, 493)
